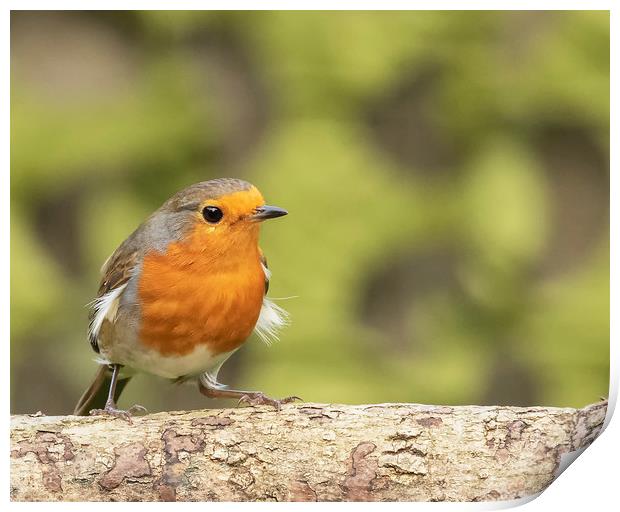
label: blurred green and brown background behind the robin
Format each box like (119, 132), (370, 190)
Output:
(11, 11), (609, 414)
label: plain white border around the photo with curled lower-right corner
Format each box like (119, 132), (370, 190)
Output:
(0, 0), (620, 511)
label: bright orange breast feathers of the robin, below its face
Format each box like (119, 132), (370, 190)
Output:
(138, 222), (265, 356)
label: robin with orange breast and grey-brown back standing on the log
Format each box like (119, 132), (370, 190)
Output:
(74, 178), (298, 421)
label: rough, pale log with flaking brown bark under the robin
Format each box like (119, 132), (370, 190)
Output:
(11, 401), (607, 501)
